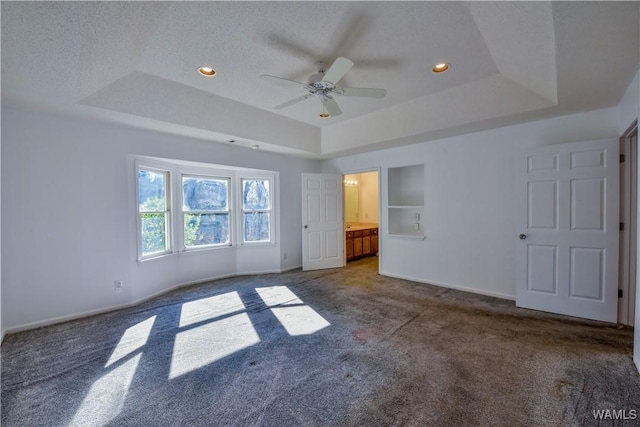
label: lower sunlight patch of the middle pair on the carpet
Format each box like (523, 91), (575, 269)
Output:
(169, 313), (260, 380)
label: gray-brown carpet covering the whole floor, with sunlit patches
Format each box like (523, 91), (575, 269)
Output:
(2, 258), (640, 426)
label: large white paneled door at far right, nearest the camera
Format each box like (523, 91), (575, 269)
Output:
(514, 139), (619, 322)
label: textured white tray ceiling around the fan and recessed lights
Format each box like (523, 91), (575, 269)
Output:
(1, 1), (640, 157)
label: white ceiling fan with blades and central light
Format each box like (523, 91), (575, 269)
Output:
(260, 57), (387, 118)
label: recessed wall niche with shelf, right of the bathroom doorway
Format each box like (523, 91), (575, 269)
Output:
(387, 165), (425, 239)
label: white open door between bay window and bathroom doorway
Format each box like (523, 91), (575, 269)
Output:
(302, 173), (344, 270)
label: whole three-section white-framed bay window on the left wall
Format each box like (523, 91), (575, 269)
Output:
(135, 156), (277, 260)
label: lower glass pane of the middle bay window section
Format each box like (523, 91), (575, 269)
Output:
(184, 213), (229, 246)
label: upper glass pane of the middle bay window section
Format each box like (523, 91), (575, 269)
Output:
(182, 176), (229, 211)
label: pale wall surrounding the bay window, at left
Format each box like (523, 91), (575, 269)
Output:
(1, 108), (320, 331)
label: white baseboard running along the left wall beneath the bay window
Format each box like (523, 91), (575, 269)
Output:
(0, 266), (301, 336)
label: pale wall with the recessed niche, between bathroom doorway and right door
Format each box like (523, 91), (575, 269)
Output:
(322, 108), (618, 298)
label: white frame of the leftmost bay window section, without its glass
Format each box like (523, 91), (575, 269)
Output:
(135, 162), (174, 260)
